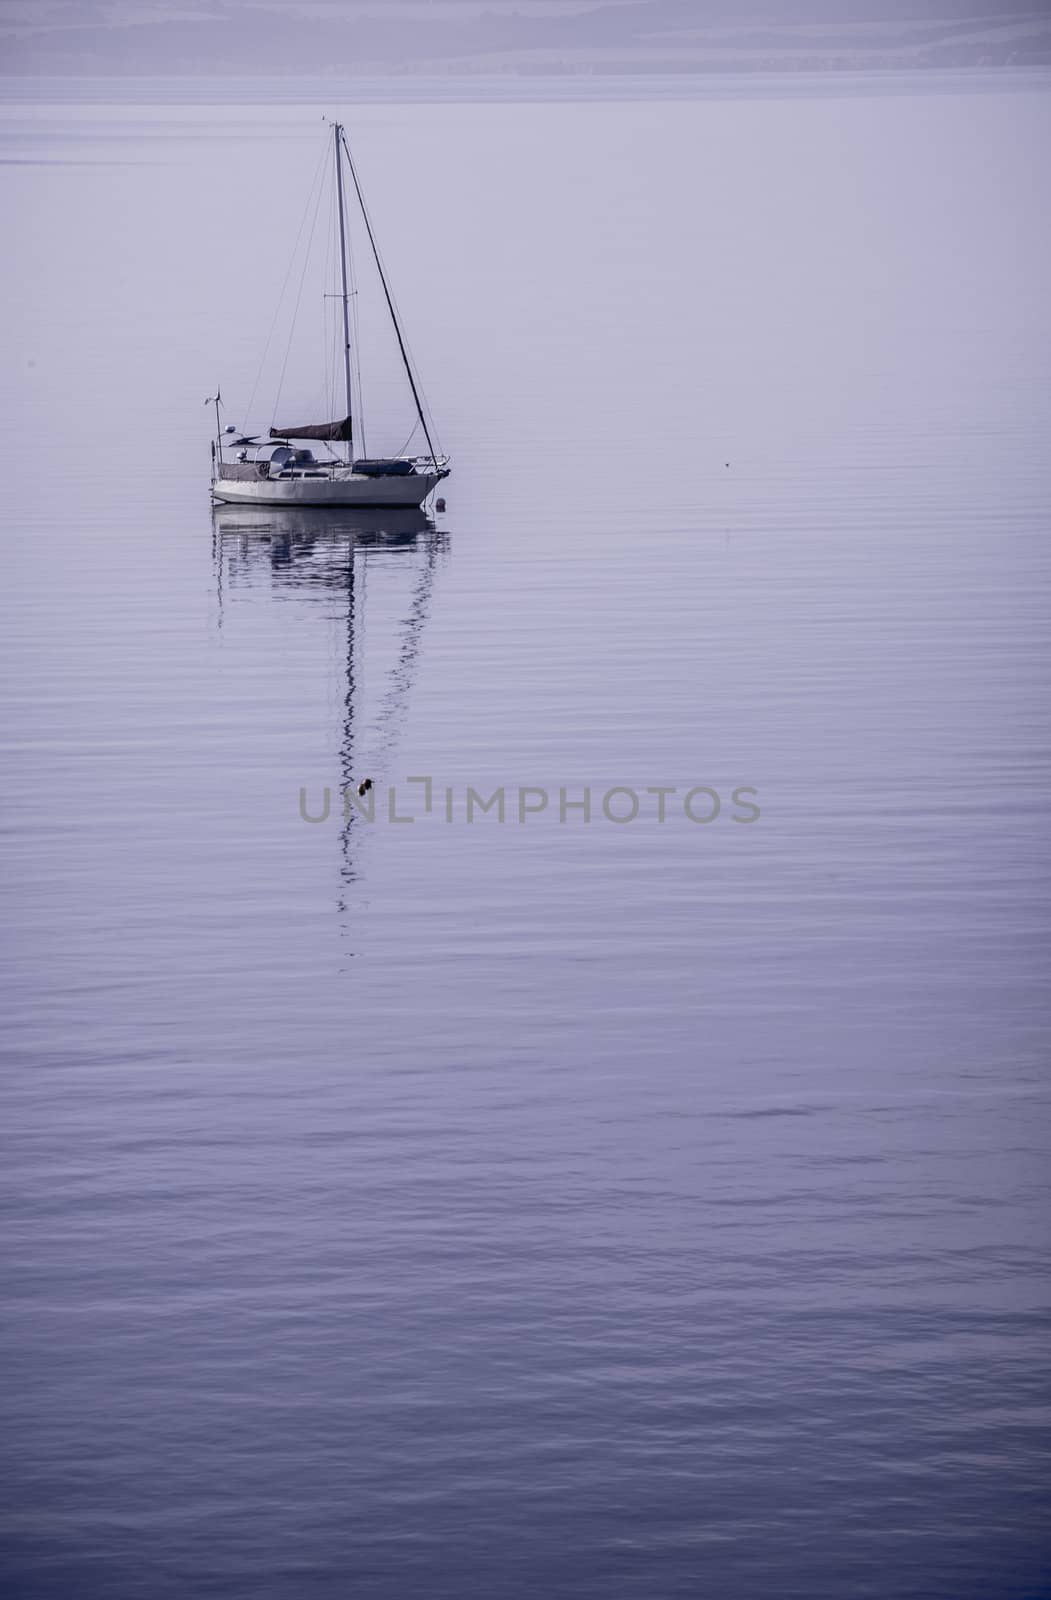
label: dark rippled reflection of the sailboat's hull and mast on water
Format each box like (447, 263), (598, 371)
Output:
(211, 504), (448, 912)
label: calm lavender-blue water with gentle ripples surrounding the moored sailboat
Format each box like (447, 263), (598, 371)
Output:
(0, 78), (1051, 1600)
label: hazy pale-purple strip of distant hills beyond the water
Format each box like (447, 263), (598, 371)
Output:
(0, 0), (1051, 75)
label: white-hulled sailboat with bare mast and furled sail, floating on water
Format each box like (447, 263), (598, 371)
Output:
(206, 122), (450, 507)
